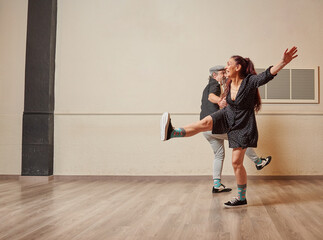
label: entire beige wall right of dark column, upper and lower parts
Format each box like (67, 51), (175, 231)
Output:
(54, 0), (323, 175)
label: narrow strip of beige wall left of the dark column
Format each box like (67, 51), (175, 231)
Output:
(0, 0), (28, 174)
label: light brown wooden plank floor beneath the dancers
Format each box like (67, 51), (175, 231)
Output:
(0, 178), (323, 240)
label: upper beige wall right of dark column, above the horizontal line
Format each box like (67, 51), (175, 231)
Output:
(56, 0), (323, 113)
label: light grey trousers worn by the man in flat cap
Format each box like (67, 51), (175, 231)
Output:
(203, 131), (258, 179)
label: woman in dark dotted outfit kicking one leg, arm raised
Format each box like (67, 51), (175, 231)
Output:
(161, 47), (298, 208)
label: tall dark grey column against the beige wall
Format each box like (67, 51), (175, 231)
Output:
(21, 0), (57, 176)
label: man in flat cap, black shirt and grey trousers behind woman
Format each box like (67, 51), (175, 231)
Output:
(200, 65), (271, 193)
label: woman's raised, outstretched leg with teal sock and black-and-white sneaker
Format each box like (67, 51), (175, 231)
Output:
(160, 112), (213, 141)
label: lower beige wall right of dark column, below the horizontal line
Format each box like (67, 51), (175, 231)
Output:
(55, 115), (323, 175)
